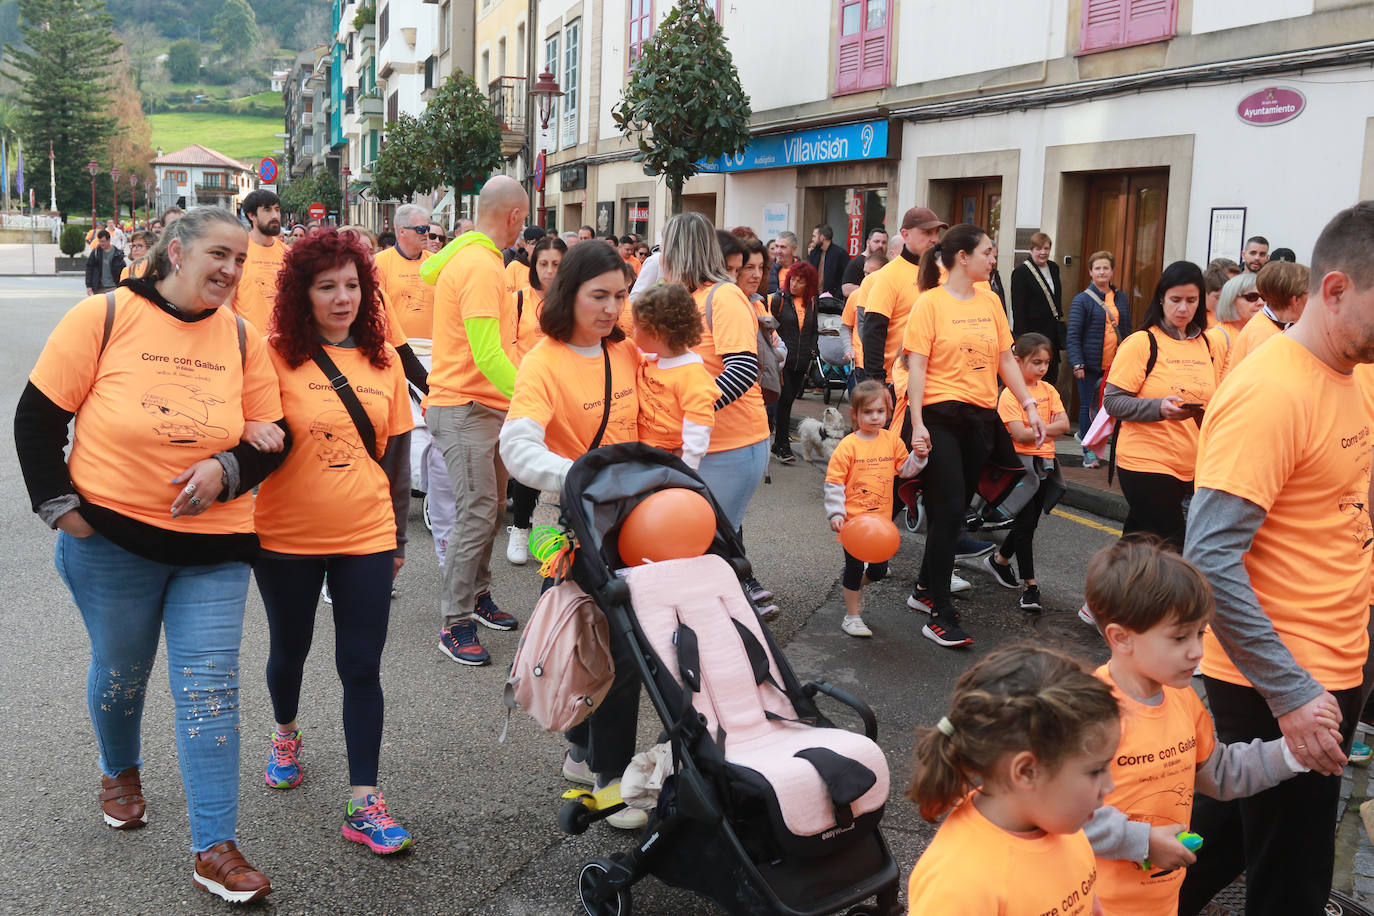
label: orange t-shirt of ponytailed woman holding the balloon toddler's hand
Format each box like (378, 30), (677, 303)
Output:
(901, 282), (1011, 408)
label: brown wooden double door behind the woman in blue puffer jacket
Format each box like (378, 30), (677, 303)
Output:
(1083, 169), (1169, 330)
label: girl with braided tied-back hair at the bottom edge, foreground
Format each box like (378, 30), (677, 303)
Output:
(907, 645), (1121, 916)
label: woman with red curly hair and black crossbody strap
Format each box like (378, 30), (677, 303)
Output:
(254, 228), (414, 853)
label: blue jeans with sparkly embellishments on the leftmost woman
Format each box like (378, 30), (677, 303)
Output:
(54, 531), (249, 853)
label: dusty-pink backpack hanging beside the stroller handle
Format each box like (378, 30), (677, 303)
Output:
(502, 581), (616, 740)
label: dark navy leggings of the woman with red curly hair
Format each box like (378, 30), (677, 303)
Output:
(253, 551), (393, 786)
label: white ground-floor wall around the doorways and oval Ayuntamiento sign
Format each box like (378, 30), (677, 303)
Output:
(890, 69), (1374, 261)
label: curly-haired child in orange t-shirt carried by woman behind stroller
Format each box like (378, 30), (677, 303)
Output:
(631, 283), (720, 471)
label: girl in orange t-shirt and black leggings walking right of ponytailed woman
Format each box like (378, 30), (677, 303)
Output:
(982, 332), (1069, 611)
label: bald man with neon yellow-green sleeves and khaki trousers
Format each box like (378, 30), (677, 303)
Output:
(425, 176), (529, 665)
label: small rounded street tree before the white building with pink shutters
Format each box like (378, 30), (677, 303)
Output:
(611, 0), (750, 214)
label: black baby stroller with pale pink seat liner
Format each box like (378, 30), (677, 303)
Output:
(559, 444), (899, 916)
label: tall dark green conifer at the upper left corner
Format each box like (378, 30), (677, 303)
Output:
(4, 0), (120, 210)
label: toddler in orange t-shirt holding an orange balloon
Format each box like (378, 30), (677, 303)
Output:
(826, 379), (926, 636)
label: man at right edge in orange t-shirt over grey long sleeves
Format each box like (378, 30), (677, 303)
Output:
(1179, 201), (1374, 916)
